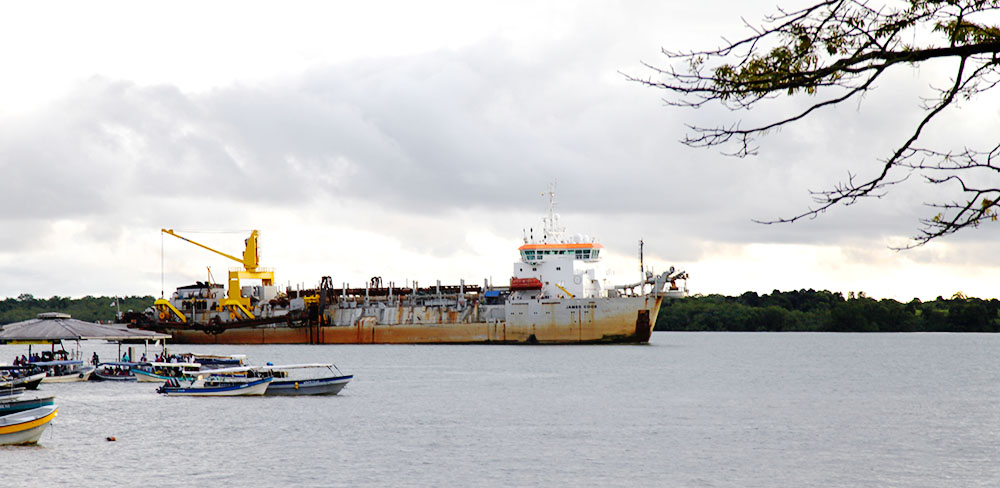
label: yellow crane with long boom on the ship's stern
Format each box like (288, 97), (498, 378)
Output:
(155, 229), (274, 322)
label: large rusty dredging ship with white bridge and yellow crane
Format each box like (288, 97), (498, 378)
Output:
(123, 188), (688, 344)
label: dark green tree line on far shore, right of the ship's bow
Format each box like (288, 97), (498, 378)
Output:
(655, 289), (1000, 332)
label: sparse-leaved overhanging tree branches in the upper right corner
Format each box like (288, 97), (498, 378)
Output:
(629, 0), (1000, 245)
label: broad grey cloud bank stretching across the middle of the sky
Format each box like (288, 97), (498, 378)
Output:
(0, 3), (997, 298)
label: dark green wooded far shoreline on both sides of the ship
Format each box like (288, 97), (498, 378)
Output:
(0, 289), (1000, 332)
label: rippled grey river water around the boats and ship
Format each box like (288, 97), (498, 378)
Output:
(0, 332), (1000, 487)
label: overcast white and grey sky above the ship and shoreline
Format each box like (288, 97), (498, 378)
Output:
(0, 0), (1000, 301)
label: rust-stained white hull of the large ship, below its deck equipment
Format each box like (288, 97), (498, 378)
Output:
(157, 295), (662, 344)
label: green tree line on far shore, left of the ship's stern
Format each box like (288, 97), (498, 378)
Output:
(0, 293), (154, 324)
